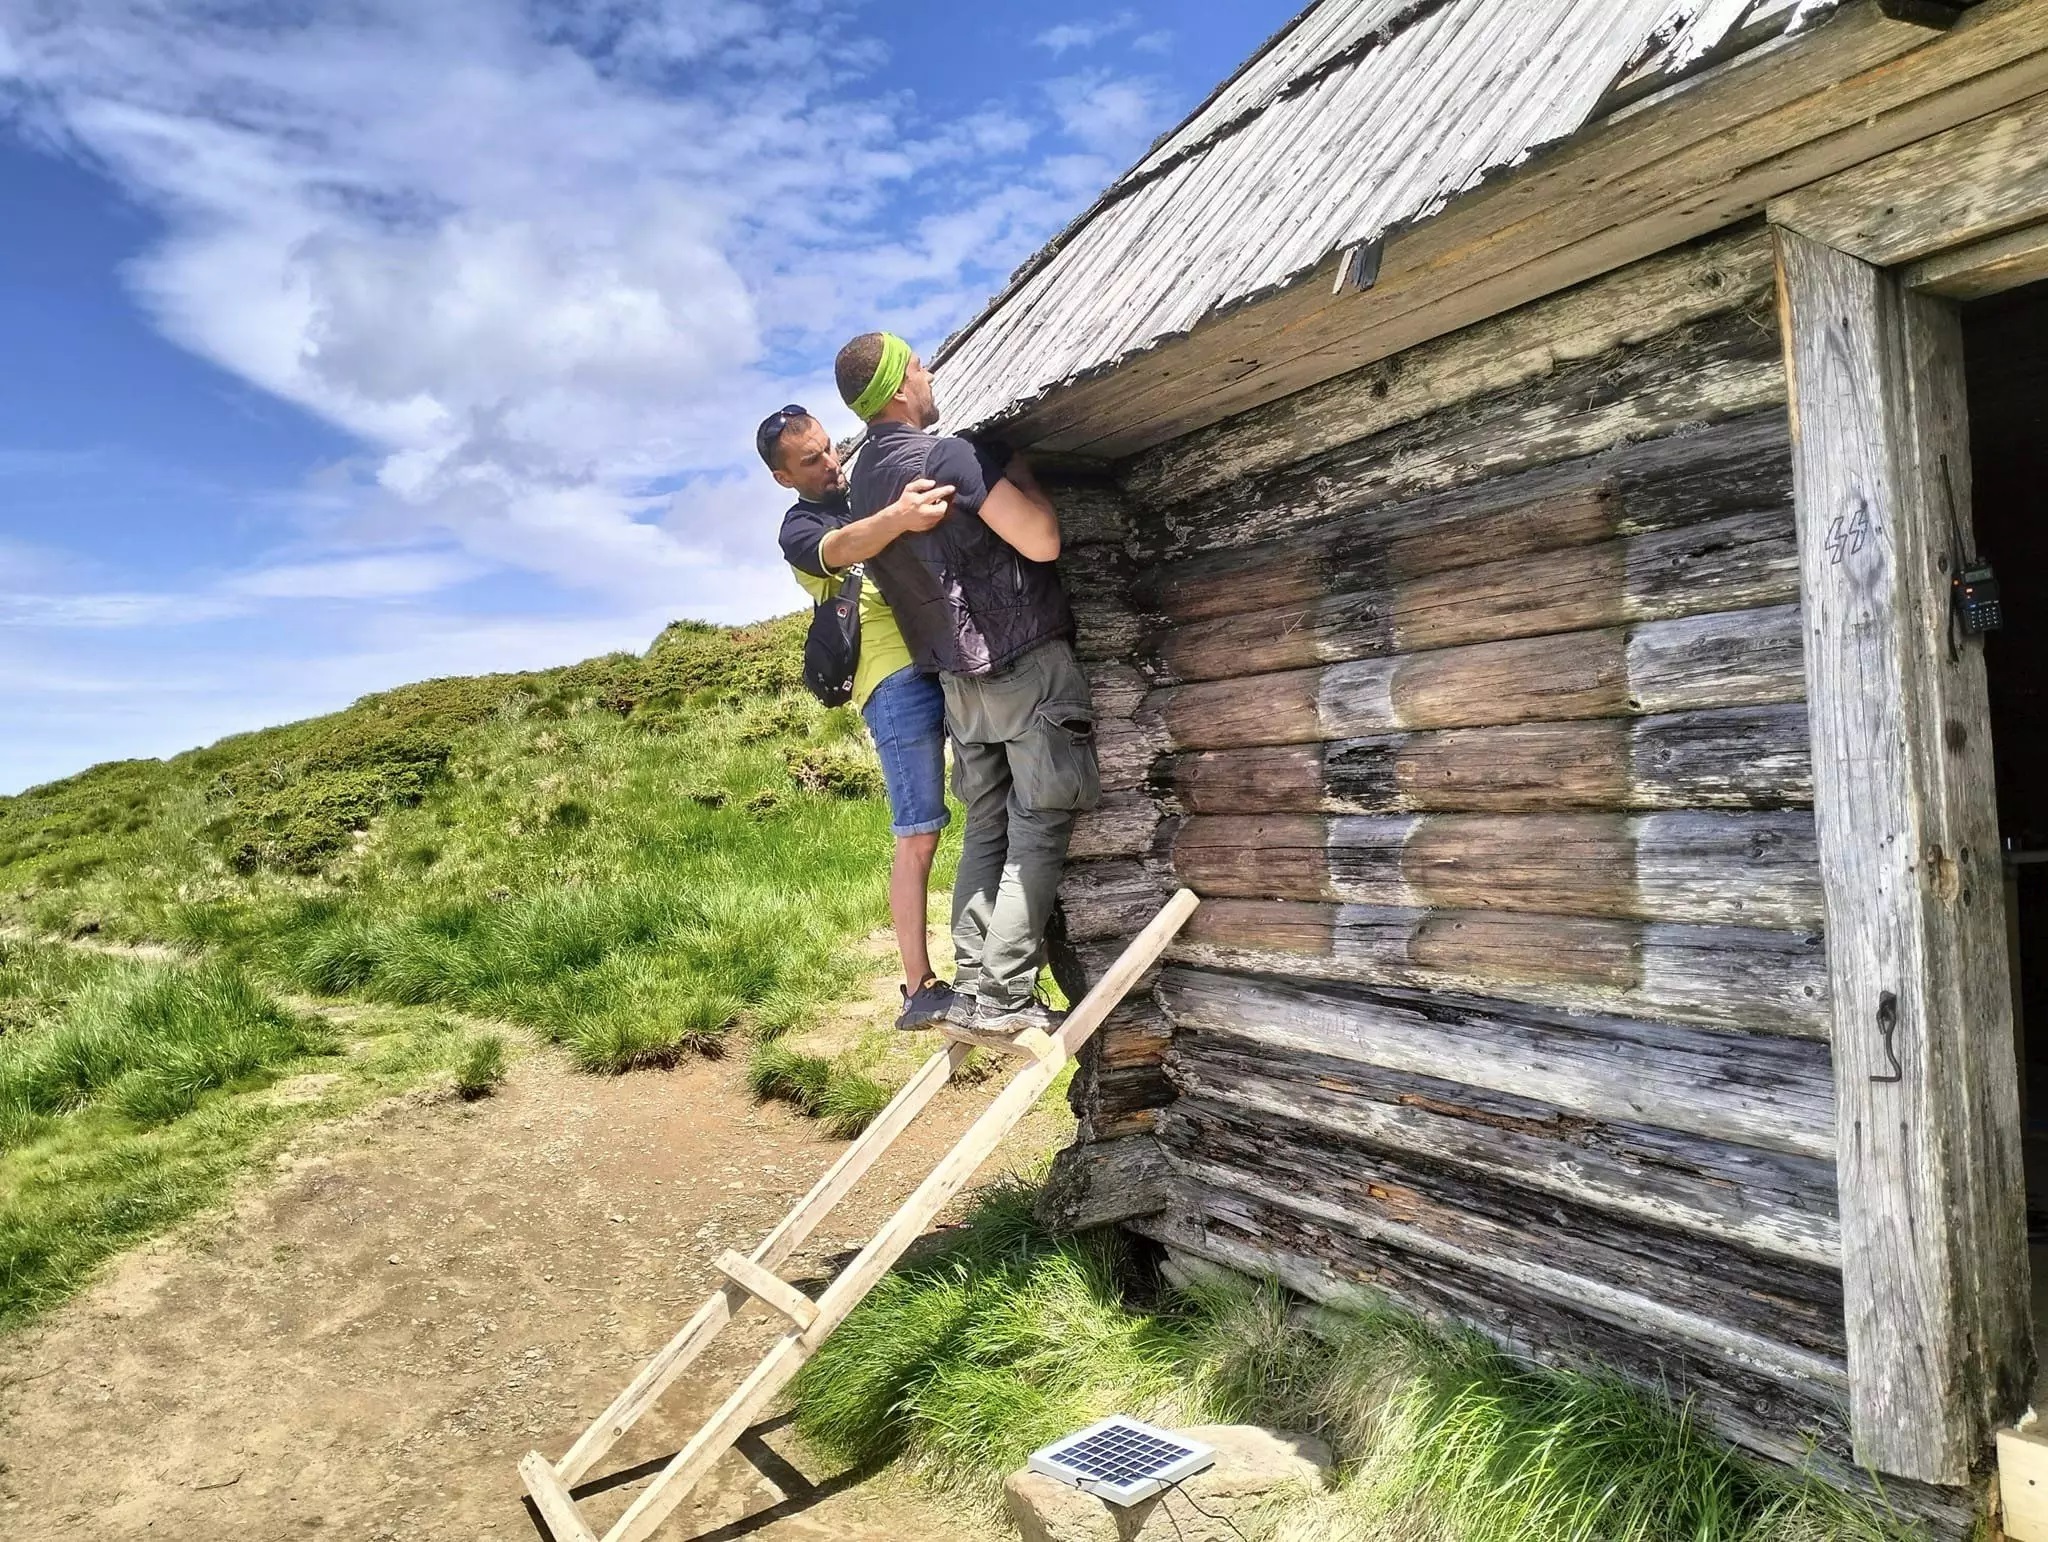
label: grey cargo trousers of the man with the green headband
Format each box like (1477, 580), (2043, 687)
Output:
(940, 641), (1102, 1008)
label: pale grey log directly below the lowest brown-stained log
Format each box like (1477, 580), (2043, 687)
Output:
(1159, 962), (1835, 1163)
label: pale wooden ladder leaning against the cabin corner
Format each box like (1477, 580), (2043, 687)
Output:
(518, 889), (1198, 1542)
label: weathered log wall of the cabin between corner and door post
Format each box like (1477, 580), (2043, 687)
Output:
(1040, 229), (1847, 1458)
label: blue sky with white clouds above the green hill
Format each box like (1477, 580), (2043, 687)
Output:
(0, 0), (1294, 793)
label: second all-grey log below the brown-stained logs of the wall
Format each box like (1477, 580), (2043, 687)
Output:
(1159, 1028), (1841, 1272)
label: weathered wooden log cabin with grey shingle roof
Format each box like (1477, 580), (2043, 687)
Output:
(921, 0), (2048, 1509)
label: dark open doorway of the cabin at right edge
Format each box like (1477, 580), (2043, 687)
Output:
(1964, 283), (2048, 1318)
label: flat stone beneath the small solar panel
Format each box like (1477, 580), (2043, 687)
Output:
(1004, 1423), (1331, 1542)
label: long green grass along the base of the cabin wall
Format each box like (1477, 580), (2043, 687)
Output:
(795, 1186), (1905, 1542)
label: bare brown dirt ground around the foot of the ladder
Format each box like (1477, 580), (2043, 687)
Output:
(0, 978), (1071, 1542)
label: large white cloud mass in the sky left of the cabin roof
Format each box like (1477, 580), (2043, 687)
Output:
(0, 0), (1089, 608)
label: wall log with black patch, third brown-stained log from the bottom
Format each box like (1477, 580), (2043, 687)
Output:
(1163, 704), (1812, 813)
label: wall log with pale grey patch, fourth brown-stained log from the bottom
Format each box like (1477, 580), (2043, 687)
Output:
(1141, 604), (1806, 749)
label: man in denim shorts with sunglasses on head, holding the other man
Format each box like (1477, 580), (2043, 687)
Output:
(754, 403), (952, 1028)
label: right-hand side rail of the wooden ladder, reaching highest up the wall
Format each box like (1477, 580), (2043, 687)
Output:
(604, 889), (1200, 1542)
